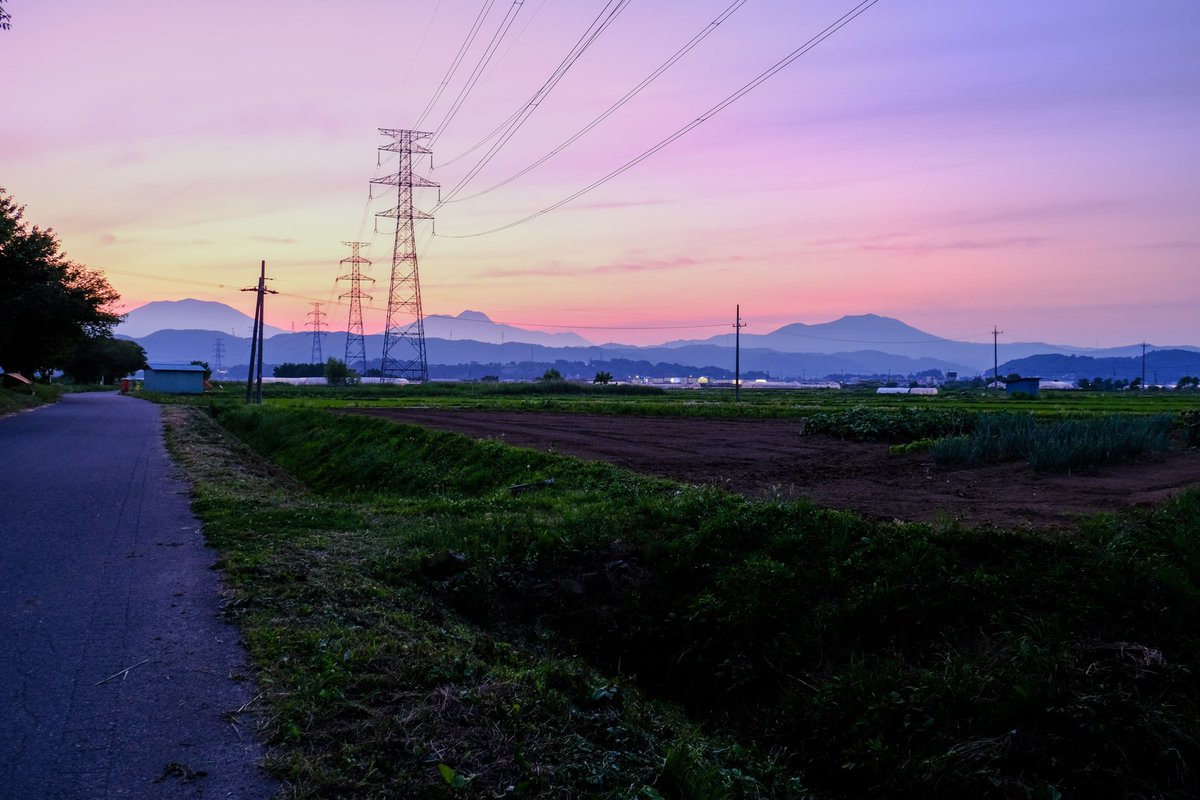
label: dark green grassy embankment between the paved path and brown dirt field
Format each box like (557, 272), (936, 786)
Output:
(166, 407), (1200, 798)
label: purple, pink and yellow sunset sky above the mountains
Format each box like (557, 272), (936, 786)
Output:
(0, 0), (1200, 347)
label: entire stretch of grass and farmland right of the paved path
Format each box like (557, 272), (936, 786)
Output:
(167, 385), (1200, 800)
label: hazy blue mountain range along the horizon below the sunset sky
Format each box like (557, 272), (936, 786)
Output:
(118, 300), (1200, 383)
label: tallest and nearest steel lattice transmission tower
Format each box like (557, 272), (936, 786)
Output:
(371, 128), (438, 383)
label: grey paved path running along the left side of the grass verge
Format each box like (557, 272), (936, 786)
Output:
(0, 393), (276, 800)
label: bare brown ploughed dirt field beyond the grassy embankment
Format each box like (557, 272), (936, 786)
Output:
(340, 409), (1200, 528)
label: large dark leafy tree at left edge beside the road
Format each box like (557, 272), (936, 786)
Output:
(0, 188), (121, 380)
